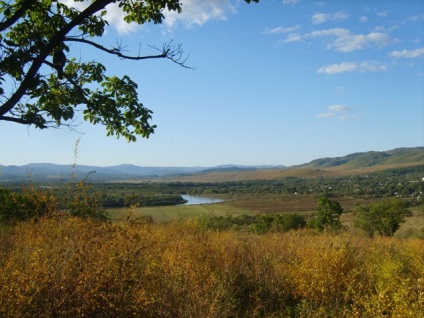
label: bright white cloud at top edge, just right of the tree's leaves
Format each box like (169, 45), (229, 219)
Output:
(164, 0), (236, 28)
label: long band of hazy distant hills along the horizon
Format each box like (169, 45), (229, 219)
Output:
(0, 147), (424, 182)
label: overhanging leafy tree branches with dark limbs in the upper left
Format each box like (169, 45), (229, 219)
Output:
(0, 0), (258, 141)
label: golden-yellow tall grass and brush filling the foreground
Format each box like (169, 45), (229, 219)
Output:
(0, 217), (424, 317)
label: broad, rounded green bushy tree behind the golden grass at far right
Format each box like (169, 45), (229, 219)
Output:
(353, 199), (411, 237)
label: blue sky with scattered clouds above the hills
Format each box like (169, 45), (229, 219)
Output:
(0, 0), (424, 167)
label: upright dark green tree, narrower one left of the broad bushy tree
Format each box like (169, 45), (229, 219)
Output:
(308, 197), (343, 231)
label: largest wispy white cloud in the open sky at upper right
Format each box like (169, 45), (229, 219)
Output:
(306, 28), (393, 53)
